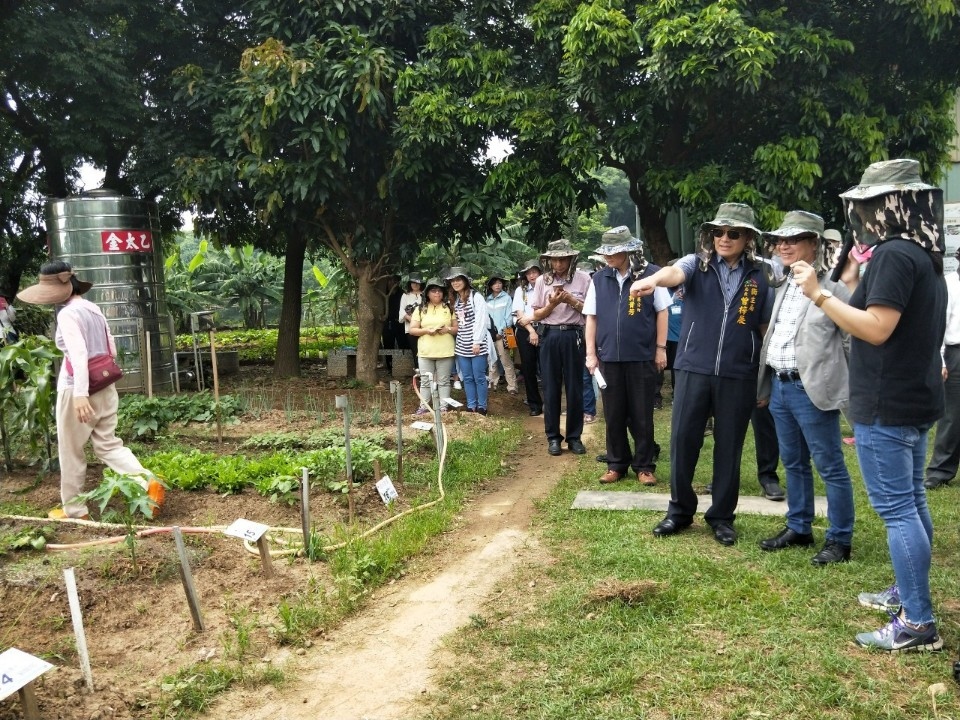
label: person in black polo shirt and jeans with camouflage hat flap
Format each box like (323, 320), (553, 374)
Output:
(792, 159), (947, 652)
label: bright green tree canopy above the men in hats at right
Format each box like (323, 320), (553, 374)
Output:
(411, 0), (960, 262)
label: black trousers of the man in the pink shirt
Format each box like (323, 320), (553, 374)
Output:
(540, 325), (587, 443)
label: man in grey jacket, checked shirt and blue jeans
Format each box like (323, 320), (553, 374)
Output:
(757, 210), (854, 565)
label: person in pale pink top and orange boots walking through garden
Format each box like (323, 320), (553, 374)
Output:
(17, 260), (166, 520)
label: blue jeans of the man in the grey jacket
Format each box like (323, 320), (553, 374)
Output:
(770, 376), (854, 545)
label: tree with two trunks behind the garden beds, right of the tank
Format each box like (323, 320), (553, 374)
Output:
(180, 0), (503, 383)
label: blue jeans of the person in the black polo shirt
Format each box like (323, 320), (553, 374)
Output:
(853, 421), (933, 625)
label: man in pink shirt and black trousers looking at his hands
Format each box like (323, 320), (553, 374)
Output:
(530, 239), (590, 455)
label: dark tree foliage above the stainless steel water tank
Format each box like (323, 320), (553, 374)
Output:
(0, 0), (248, 291)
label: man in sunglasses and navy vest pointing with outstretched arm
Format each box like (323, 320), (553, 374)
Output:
(631, 203), (773, 545)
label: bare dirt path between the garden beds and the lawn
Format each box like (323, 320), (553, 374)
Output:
(205, 417), (597, 720)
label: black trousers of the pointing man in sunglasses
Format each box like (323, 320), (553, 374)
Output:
(667, 370), (757, 526)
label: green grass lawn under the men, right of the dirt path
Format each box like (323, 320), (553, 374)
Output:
(421, 408), (960, 720)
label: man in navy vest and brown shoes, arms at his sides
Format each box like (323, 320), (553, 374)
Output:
(583, 226), (671, 485)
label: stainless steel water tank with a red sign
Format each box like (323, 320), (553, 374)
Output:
(47, 190), (175, 392)
